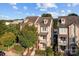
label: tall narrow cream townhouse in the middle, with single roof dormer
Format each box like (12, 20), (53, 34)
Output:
(37, 17), (53, 50)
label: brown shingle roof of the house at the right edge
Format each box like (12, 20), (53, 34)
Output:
(59, 16), (79, 27)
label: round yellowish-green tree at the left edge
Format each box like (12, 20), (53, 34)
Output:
(0, 32), (16, 47)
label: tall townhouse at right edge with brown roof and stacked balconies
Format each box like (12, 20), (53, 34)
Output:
(58, 16), (79, 54)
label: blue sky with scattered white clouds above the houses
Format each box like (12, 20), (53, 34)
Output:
(0, 3), (79, 19)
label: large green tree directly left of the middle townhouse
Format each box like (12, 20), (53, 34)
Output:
(19, 25), (37, 53)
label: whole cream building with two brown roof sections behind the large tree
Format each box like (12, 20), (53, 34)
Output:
(24, 16), (53, 50)
